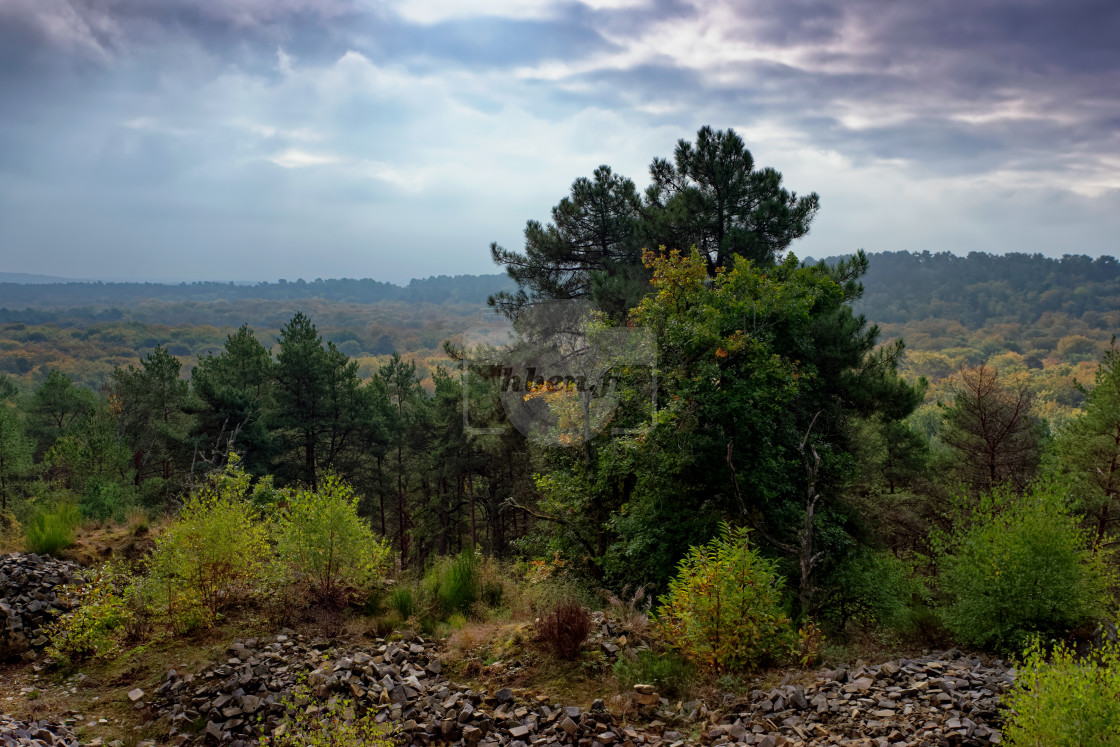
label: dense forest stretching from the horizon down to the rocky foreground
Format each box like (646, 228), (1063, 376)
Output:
(0, 128), (1120, 743)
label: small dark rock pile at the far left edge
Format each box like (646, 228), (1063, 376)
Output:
(0, 552), (82, 661)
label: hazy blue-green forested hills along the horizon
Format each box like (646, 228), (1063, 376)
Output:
(0, 252), (1120, 330)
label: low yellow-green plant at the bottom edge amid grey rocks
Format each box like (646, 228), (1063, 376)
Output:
(258, 682), (395, 747)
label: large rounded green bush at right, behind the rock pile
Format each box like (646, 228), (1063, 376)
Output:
(940, 484), (1108, 650)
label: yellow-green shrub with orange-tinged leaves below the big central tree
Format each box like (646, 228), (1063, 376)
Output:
(655, 523), (794, 671)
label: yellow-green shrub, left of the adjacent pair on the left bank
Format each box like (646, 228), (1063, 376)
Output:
(151, 465), (270, 627)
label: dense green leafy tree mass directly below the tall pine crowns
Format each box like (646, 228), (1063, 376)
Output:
(591, 251), (922, 586)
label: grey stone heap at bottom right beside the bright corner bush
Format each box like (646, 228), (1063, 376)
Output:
(703, 650), (1015, 747)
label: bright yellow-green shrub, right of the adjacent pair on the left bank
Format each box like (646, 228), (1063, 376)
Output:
(277, 475), (390, 598)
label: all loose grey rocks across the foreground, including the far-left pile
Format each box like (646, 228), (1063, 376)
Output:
(0, 553), (1014, 747)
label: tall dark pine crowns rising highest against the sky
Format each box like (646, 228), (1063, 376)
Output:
(489, 127), (820, 320)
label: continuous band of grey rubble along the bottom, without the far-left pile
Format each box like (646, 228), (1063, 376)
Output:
(144, 634), (1012, 747)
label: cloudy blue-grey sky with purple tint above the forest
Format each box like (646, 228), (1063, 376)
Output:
(0, 0), (1120, 282)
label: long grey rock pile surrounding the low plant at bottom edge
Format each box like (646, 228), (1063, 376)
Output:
(153, 634), (661, 747)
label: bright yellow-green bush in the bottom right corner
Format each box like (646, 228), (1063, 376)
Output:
(1004, 639), (1120, 747)
